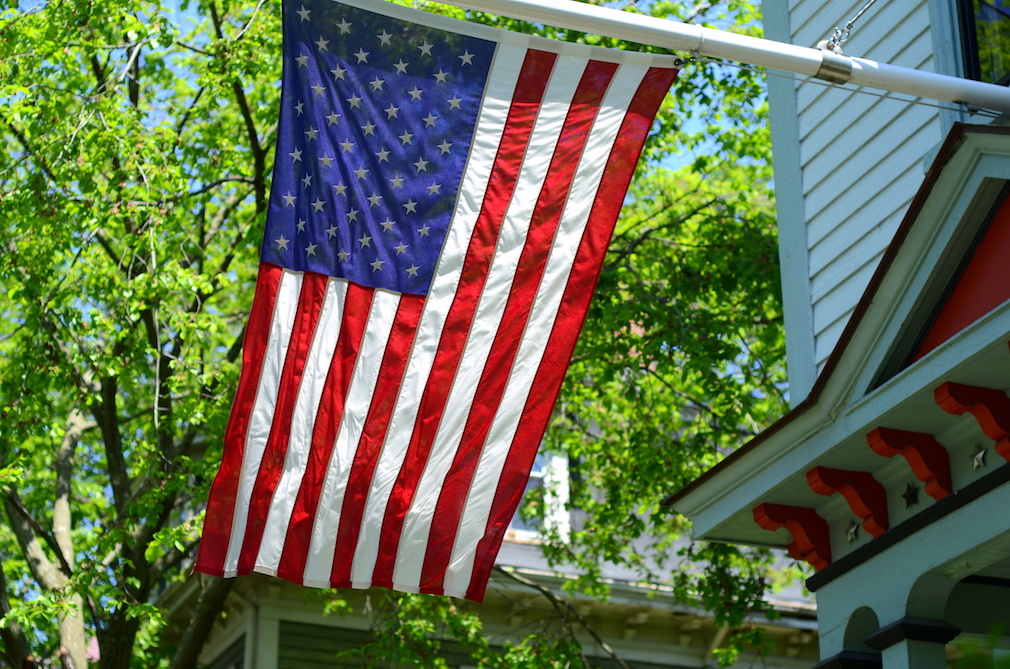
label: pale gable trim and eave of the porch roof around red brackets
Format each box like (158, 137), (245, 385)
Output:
(664, 125), (1010, 560)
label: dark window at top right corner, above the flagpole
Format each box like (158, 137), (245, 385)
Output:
(958, 0), (1010, 85)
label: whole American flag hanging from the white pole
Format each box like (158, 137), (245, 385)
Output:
(196, 0), (676, 601)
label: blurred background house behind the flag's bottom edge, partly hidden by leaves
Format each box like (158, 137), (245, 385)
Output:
(171, 459), (817, 669)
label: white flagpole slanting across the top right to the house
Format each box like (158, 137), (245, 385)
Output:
(450, 0), (1010, 113)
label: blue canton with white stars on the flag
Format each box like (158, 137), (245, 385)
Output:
(262, 0), (495, 294)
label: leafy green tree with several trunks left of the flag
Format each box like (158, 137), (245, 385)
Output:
(0, 1), (279, 667)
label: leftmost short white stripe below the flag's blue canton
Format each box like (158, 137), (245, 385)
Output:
(224, 270), (303, 576)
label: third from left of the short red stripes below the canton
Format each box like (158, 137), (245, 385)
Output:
(277, 283), (375, 583)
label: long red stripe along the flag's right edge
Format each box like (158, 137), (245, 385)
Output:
(467, 68), (677, 602)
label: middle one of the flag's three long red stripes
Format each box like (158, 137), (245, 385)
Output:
(420, 61), (617, 594)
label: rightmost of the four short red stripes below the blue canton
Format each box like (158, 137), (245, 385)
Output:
(329, 295), (424, 587)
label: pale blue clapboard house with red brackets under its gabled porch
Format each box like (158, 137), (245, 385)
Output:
(668, 0), (1010, 669)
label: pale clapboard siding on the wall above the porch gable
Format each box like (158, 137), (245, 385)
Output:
(773, 0), (942, 379)
